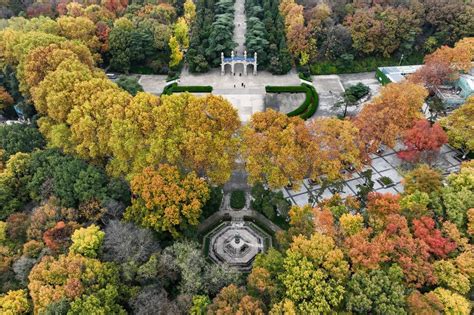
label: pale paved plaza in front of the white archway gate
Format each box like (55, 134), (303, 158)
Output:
(139, 69), (381, 122)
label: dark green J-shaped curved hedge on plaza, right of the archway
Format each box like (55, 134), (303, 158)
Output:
(265, 83), (319, 119)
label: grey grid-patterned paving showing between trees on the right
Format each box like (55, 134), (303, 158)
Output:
(281, 145), (461, 206)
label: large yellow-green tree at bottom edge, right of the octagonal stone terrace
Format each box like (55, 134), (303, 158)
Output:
(279, 233), (349, 313)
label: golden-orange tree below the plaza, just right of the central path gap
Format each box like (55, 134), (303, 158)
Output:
(242, 109), (309, 188)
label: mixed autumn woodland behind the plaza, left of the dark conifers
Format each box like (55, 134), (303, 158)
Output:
(0, 0), (196, 74)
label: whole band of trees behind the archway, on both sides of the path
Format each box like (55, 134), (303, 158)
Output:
(0, 0), (474, 74)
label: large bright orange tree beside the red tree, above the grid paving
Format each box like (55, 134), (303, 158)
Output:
(354, 81), (428, 153)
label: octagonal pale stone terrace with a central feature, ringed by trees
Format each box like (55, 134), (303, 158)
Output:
(204, 221), (272, 271)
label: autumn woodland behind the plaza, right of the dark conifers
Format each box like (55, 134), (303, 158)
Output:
(280, 0), (474, 74)
